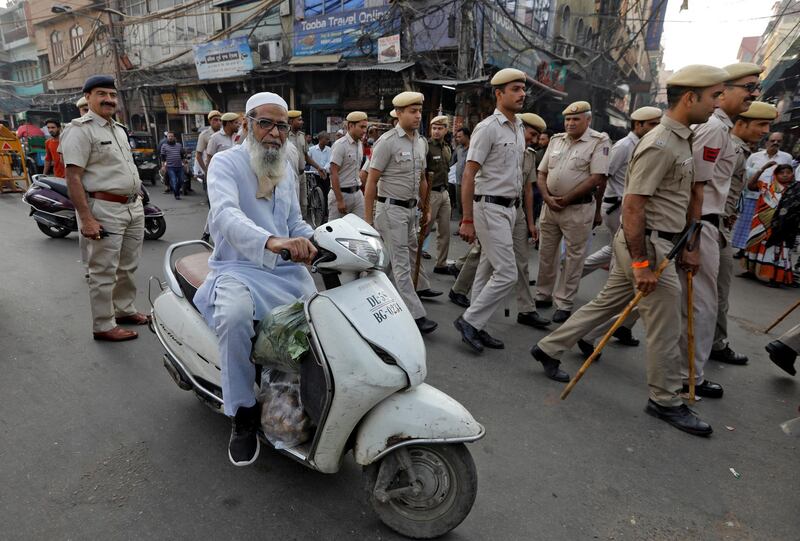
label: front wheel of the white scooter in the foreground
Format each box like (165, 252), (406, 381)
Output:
(364, 443), (478, 539)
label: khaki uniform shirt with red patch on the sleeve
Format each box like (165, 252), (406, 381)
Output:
(693, 108), (736, 214)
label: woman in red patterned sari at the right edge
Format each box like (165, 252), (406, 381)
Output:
(743, 164), (800, 287)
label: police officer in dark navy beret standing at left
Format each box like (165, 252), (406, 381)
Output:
(61, 75), (149, 342)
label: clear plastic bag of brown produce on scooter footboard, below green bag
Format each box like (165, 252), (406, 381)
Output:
(259, 367), (311, 449)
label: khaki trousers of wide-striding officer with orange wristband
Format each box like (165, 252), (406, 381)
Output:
(538, 230), (683, 407)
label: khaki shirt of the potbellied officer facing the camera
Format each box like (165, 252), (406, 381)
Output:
(539, 128), (611, 196)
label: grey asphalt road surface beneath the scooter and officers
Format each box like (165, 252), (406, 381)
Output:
(0, 184), (800, 541)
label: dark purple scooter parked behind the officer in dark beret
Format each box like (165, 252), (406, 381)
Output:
(22, 175), (167, 240)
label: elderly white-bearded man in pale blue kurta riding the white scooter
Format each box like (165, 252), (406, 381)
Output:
(194, 92), (317, 466)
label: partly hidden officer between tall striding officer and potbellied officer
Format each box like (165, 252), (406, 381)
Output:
(512, 113), (550, 329)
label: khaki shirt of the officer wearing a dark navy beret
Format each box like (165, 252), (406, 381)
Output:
(61, 111), (142, 195)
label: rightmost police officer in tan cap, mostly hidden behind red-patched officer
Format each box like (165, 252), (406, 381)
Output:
(710, 101), (778, 364)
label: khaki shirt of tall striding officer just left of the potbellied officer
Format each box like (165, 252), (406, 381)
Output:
(467, 109), (525, 198)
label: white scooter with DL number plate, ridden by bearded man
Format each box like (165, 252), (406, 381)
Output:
(151, 214), (485, 538)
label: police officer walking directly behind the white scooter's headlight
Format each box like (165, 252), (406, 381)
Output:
(364, 92), (442, 333)
